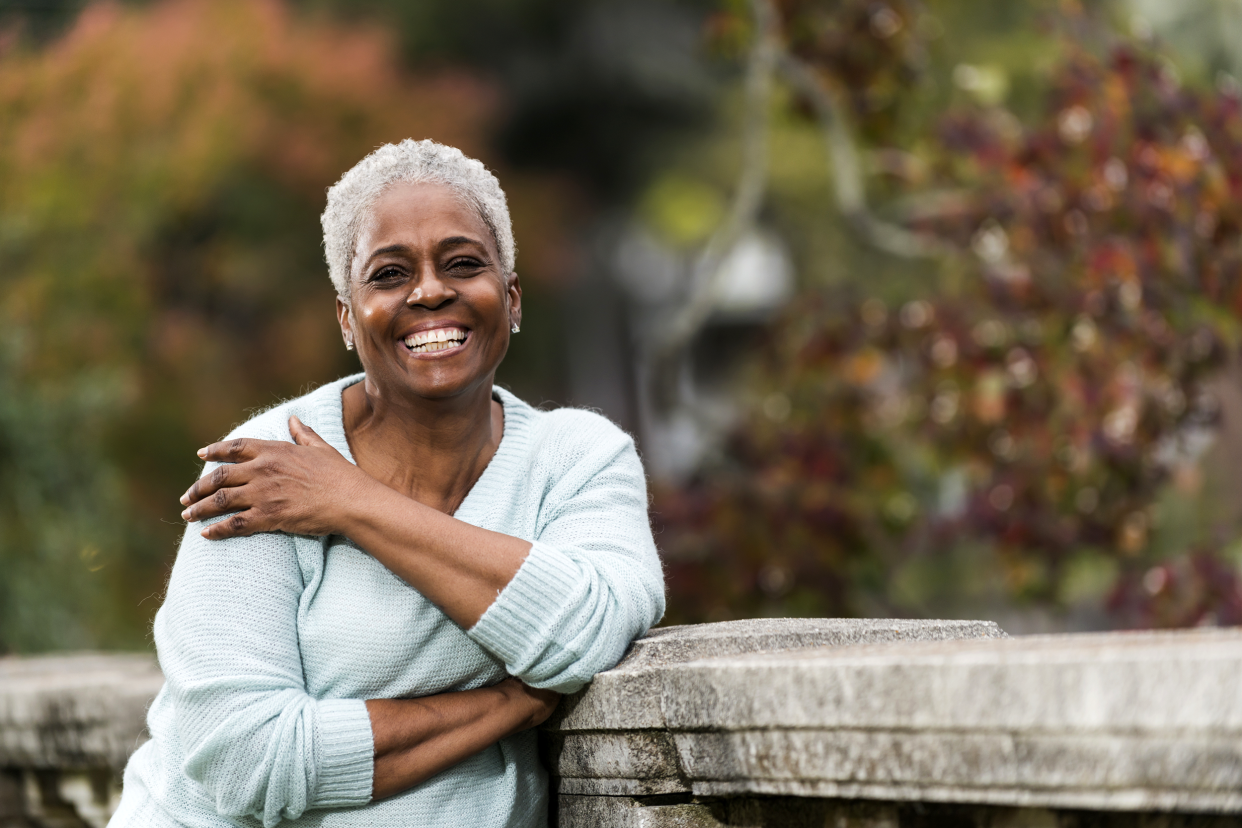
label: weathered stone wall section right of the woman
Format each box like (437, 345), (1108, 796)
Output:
(546, 622), (1242, 828)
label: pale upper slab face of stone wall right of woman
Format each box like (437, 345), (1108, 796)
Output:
(658, 629), (1242, 739)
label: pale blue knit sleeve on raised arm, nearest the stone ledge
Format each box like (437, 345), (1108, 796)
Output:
(468, 425), (664, 693)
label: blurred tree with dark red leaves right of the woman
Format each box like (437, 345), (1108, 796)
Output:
(656, 0), (1242, 626)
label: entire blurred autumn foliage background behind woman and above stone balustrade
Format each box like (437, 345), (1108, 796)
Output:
(0, 0), (1242, 652)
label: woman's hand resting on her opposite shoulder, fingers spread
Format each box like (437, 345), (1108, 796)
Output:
(181, 417), (374, 540)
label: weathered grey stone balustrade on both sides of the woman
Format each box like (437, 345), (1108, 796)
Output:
(0, 619), (1242, 828)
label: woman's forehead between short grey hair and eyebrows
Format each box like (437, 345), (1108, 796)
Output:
(355, 181), (496, 256)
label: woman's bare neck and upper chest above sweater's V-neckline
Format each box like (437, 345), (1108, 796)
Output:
(342, 377), (504, 514)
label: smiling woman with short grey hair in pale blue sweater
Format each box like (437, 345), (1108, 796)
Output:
(112, 140), (663, 828)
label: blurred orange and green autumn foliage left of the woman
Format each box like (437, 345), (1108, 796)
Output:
(0, 0), (559, 652)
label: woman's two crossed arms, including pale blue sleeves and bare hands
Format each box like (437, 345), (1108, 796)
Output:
(171, 412), (664, 824)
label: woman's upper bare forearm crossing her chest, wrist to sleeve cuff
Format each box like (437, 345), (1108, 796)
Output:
(338, 482), (530, 629)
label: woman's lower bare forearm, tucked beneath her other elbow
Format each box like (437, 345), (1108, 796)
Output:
(366, 679), (559, 799)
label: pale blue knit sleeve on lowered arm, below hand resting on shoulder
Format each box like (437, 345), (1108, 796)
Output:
(155, 444), (374, 828)
